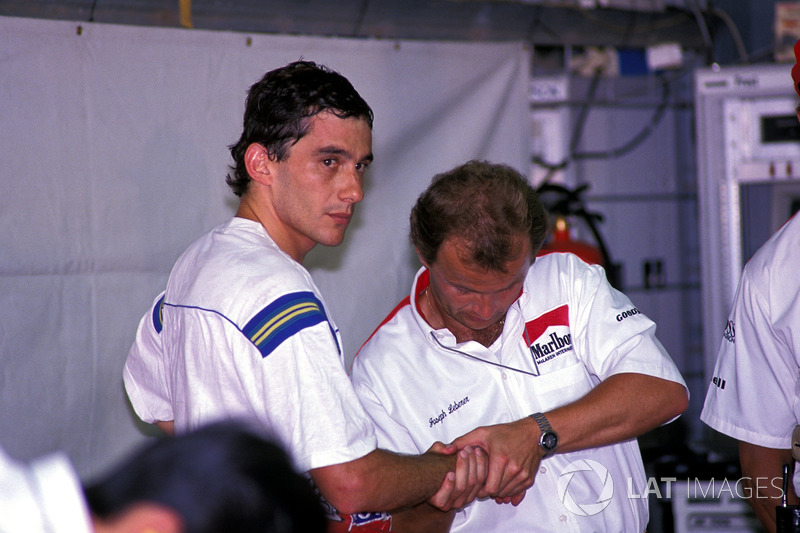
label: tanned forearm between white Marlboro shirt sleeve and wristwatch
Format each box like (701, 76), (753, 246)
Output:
(546, 373), (689, 452)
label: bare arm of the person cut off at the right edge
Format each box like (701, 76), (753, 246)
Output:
(739, 441), (799, 533)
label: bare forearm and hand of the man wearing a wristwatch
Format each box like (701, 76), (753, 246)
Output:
(454, 373), (689, 499)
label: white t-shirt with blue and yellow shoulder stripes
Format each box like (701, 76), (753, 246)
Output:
(124, 218), (376, 471)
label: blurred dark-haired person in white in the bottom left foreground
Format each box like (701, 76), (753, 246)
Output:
(0, 422), (325, 533)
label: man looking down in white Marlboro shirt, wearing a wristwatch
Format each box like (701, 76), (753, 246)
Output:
(352, 161), (688, 533)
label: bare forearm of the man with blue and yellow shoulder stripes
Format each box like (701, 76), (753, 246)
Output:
(309, 450), (456, 514)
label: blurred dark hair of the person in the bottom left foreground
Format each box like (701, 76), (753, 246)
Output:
(85, 422), (325, 533)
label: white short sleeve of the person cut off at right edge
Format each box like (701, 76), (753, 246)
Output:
(700, 269), (798, 449)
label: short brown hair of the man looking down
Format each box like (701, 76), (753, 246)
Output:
(410, 161), (548, 271)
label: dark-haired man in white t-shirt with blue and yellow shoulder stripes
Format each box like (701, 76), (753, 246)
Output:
(124, 61), (486, 530)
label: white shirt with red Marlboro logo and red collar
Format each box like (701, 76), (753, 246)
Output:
(352, 254), (685, 533)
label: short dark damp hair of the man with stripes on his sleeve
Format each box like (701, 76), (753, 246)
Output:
(225, 61), (373, 196)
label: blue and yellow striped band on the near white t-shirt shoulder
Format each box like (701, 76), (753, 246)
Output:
(242, 291), (328, 357)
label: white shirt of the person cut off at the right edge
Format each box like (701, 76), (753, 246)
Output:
(700, 212), (800, 448)
